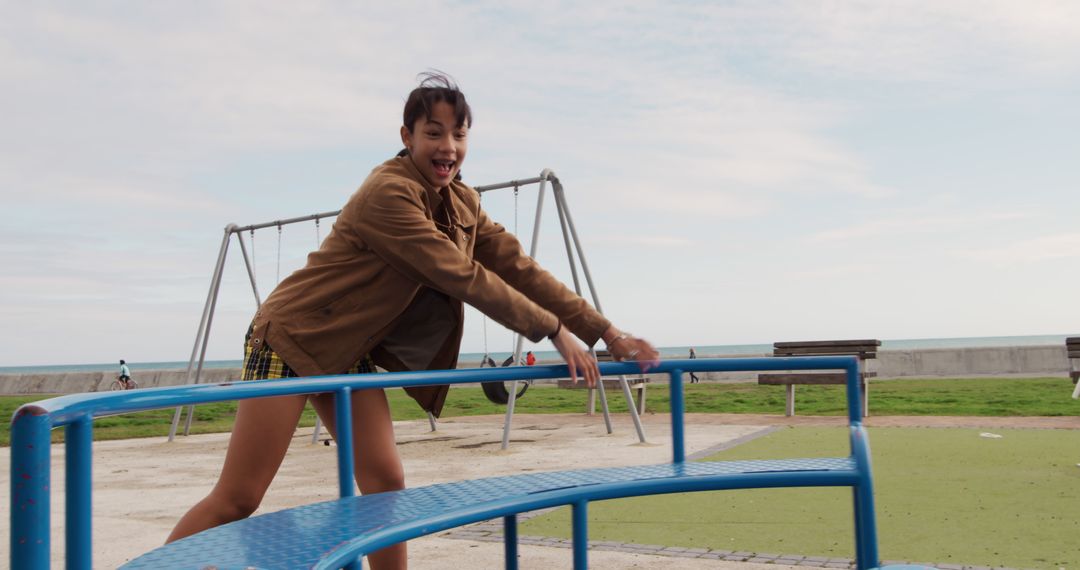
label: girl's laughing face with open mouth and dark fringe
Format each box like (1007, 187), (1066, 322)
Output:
(402, 101), (469, 188)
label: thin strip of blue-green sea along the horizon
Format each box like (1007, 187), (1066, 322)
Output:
(0, 335), (1080, 375)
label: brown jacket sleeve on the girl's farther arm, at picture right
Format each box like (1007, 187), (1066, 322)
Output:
(474, 209), (611, 347)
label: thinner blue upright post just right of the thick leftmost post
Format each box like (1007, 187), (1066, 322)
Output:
(64, 415), (94, 570)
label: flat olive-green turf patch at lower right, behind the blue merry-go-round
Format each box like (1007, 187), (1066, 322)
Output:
(521, 428), (1080, 569)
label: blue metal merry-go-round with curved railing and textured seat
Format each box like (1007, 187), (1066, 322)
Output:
(10, 356), (879, 570)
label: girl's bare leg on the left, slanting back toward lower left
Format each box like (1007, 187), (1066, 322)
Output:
(165, 395), (308, 542)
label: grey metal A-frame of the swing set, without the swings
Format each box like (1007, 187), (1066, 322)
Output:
(168, 168), (646, 449)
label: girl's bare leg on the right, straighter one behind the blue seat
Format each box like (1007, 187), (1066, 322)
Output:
(311, 390), (408, 570)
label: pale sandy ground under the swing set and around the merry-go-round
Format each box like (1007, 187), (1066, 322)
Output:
(0, 413), (1080, 570)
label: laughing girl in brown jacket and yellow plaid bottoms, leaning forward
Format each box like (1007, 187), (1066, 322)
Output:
(168, 73), (659, 570)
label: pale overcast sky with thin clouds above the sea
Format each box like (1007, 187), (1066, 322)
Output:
(0, 1), (1080, 366)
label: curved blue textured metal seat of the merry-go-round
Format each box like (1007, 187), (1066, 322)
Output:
(122, 458), (859, 569)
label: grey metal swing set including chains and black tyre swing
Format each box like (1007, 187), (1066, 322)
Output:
(168, 168), (646, 449)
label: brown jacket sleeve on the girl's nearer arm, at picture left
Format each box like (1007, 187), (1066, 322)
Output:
(349, 181), (558, 342)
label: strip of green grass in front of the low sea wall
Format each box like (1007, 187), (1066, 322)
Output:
(0, 378), (1080, 446)
